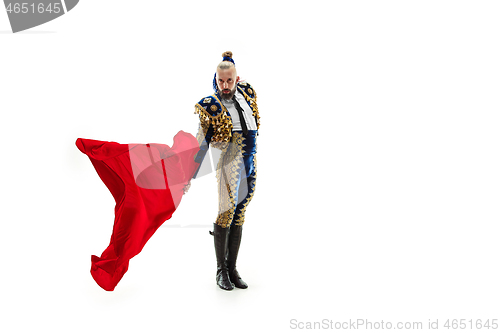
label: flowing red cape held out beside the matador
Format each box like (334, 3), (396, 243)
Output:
(76, 131), (199, 291)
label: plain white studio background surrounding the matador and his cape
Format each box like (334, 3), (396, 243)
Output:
(0, 0), (500, 332)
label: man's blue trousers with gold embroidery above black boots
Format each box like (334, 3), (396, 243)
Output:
(215, 131), (257, 228)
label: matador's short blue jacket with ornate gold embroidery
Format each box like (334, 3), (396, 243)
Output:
(194, 82), (260, 163)
